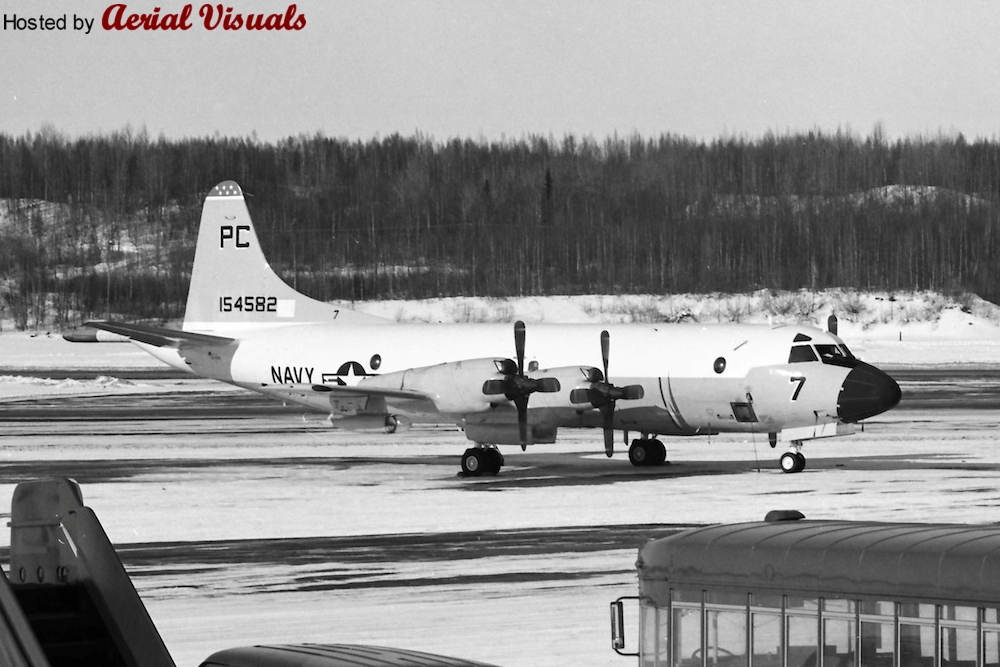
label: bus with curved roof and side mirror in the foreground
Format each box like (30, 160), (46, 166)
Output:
(611, 511), (1000, 667)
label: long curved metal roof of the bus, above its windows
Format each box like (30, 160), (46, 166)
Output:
(637, 521), (1000, 605)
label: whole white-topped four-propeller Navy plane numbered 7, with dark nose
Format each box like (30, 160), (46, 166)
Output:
(72, 181), (900, 475)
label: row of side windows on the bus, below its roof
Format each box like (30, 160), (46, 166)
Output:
(639, 589), (1000, 667)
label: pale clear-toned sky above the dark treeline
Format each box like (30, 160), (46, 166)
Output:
(0, 0), (1000, 141)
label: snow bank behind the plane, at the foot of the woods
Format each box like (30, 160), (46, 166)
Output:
(0, 290), (1000, 380)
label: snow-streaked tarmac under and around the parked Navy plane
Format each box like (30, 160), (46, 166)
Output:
(0, 369), (1000, 665)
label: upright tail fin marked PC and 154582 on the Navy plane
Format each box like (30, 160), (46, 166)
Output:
(184, 181), (388, 331)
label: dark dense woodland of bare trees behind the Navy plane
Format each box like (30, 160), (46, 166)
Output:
(0, 128), (1000, 326)
